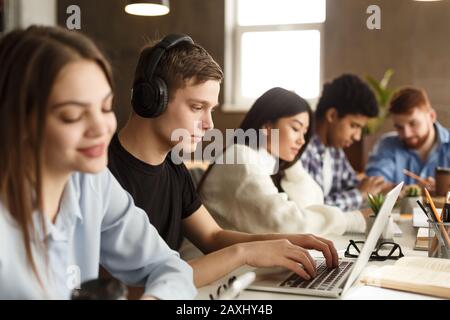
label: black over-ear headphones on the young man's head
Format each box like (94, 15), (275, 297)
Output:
(131, 34), (194, 118)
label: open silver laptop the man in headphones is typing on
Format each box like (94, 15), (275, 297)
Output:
(247, 182), (403, 297)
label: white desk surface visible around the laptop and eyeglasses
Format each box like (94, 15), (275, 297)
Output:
(196, 215), (437, 300)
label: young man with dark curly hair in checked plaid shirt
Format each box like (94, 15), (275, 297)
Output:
(301, 74), (385, 211)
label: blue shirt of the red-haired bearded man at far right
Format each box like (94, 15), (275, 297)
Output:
(366, 123), (450, 184)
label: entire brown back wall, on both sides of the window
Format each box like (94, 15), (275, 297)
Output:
(58, 0), (450, 136)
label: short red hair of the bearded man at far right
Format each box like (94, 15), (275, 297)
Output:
(389, 87), (431, 114)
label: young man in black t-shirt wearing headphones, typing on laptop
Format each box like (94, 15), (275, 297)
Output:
(108, 35), (338, 287)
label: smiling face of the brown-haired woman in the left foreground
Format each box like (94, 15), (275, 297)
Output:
(43, 60), (116, 174)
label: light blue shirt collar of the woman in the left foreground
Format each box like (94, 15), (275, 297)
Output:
(33, 178), (83, 241)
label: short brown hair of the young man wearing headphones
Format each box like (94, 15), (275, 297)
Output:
(133, 41), (223, 100)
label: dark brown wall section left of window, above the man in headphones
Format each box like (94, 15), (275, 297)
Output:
(58, 0), (224, 127)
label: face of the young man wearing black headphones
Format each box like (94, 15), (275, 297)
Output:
(153, 79), (220, 152)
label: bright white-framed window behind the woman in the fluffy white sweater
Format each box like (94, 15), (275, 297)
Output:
(224, 0), (325, 111)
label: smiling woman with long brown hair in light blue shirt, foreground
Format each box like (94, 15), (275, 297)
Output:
(0, 27), (196, 299)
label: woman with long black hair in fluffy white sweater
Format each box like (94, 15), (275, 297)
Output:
(199, 88), (365, 234)
